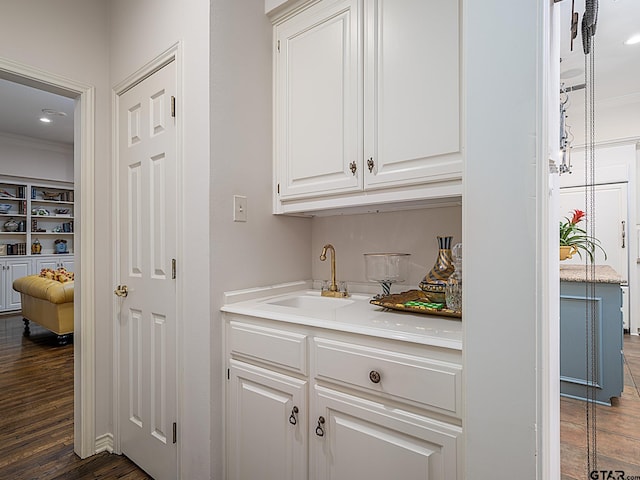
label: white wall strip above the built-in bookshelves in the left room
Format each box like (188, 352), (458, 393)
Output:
(0, 133), (73, 182)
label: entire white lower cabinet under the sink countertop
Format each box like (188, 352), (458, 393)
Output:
(224, 313), (463, 480)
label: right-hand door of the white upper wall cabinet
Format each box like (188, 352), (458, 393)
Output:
(364, 0), (462, 189)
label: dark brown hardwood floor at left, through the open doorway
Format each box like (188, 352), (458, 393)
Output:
(0, 315), (151, 480)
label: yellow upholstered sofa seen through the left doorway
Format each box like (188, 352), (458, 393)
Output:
(13, 275), (73, 345)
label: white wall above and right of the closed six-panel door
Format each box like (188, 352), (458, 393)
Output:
(106, 0), (211, 479)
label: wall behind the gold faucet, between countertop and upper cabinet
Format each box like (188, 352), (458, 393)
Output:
(311, 207), (462, 292)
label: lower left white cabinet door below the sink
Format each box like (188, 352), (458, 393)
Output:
(227, 360), (307, 480)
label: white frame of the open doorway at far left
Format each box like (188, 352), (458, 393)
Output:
(0, 58), (96, 458)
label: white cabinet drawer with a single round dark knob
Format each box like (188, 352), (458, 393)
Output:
(314, 338), (462, 417)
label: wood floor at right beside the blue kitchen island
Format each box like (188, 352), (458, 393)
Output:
(560, 335), (640, 480)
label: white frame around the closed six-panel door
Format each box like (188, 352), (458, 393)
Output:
(111, 42), (185, 470)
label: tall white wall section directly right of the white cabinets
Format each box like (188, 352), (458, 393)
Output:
(462, 0), (550, 479)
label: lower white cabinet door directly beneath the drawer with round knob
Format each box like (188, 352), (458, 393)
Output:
(309, 386), (462, 480)
